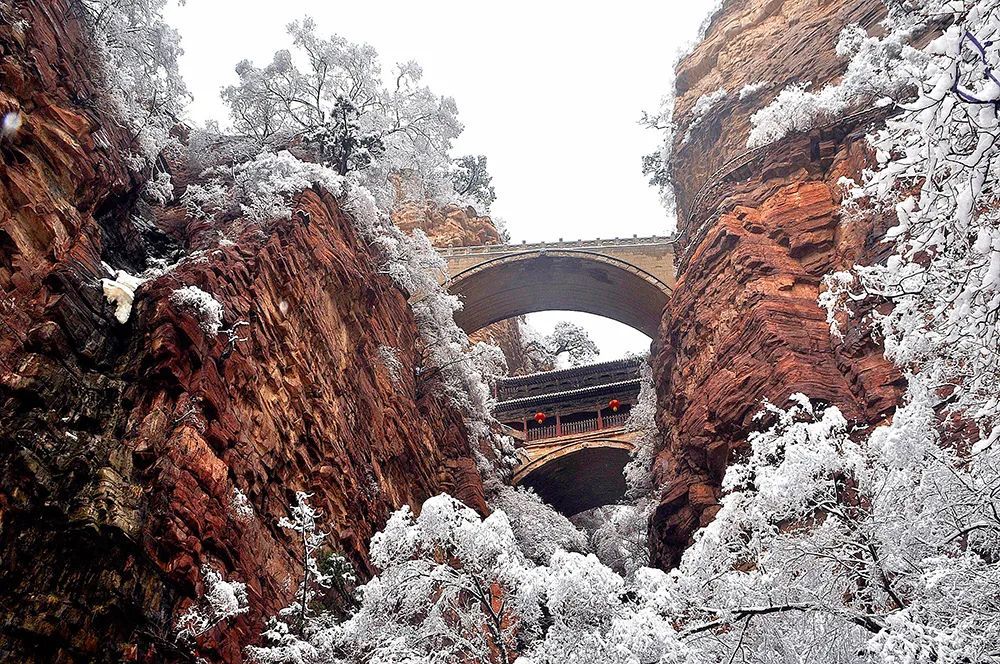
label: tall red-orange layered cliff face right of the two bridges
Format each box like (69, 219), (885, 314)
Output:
(650, 0), (901, 567)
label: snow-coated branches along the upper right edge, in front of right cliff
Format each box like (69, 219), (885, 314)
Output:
(821, 0), (1000, 452)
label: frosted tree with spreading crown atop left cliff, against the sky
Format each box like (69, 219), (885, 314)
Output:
(223, 18), (468, 208)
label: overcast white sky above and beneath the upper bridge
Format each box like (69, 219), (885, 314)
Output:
(167, 0), (715, 359)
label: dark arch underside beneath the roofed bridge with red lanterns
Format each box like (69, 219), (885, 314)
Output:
(516, 441), (632, 516)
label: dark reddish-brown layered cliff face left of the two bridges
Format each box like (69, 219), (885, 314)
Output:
(0, 6), (486, 662)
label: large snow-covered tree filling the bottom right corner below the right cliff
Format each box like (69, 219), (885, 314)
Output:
(656, 393), (1000, 663)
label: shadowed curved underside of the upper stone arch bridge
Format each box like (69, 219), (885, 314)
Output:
(448, 251), (670, 338)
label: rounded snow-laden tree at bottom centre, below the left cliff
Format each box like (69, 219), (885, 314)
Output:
(252, 496), (539, 664)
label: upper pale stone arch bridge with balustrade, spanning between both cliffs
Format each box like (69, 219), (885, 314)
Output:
(439, 236), (674, 337)
